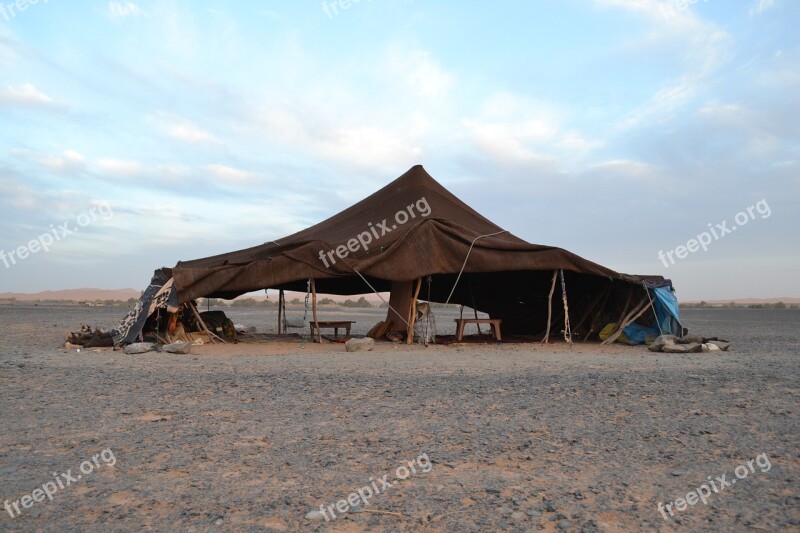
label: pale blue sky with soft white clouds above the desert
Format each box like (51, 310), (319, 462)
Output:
(0, 0), (800, 300)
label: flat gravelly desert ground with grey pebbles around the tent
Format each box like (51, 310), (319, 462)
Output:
(0, 306), (800, 532)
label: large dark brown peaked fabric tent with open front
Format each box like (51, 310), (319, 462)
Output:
(158, 165), (680, 341)
